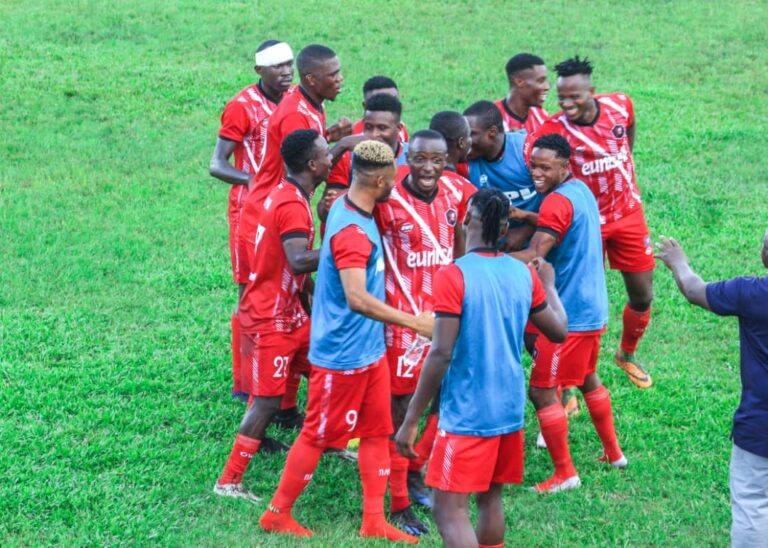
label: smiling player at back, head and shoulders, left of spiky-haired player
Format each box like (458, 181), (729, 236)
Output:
(496, 53), (549, 134)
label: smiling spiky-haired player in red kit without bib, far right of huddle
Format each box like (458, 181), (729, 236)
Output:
(526, 57), (655, 388)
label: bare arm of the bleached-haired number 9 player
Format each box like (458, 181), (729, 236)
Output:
(339, 268), (434, 338)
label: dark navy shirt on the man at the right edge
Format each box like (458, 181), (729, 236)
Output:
(707, 276), (768, 458)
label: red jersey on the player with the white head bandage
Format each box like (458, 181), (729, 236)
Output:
(219, 84), (277, 217)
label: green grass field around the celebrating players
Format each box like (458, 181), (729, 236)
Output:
(0, 0), (768, 546)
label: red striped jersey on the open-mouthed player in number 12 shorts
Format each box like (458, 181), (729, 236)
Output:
(374, 166), (475, 356)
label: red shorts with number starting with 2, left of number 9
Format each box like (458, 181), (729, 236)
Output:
(240, 322), (309, 397)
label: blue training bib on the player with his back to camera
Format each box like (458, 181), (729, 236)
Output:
(440, 251), (533, 436)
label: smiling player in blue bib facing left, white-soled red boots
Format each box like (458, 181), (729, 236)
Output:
(512, 134), (627, 493)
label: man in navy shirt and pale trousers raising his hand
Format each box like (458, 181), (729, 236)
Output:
(656, 231), (768, 547)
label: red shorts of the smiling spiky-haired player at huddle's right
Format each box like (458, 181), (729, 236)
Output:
(601, 209), (656, 272)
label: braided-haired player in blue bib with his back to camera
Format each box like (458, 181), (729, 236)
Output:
(395, 187), (568, 546)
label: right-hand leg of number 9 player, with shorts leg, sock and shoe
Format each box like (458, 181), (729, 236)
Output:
(356, 357), (418, 543)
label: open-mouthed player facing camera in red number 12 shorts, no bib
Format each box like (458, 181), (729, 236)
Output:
(374, 129), (475, 535)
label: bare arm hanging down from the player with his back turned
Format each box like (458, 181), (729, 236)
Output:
(395, 315), (461, 459)
